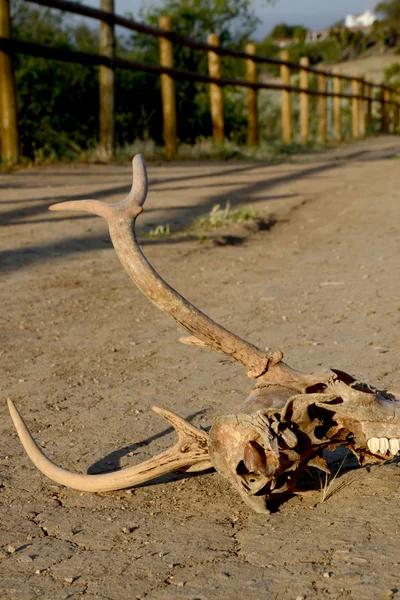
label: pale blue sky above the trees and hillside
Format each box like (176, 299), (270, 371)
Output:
(83, 0), (378, 38)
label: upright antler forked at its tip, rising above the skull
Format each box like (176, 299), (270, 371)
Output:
(50, 155), (281, 377)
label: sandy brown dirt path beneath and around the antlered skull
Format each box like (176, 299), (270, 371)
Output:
(0, 137), (400, 600)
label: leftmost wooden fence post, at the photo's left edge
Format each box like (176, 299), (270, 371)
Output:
(0, 0), (19, 166)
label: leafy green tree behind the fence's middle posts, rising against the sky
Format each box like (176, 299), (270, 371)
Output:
(125, 0), (268, 143)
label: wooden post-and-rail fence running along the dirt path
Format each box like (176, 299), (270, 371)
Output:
(0, 0), (400, 165)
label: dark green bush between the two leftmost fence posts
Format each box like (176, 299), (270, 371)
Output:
(13, 2), (98, 160)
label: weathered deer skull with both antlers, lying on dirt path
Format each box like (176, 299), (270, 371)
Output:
(8, 155), (400, 513)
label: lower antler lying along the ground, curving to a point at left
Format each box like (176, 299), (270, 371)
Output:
(7, 399), (212, 492)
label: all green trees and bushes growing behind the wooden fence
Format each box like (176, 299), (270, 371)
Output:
(4, 0), (400, 163)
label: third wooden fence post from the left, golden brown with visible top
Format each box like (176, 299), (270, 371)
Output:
(158, 16), (178, 158)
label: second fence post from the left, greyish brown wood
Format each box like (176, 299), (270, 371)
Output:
(99, 0), (115, 159)
